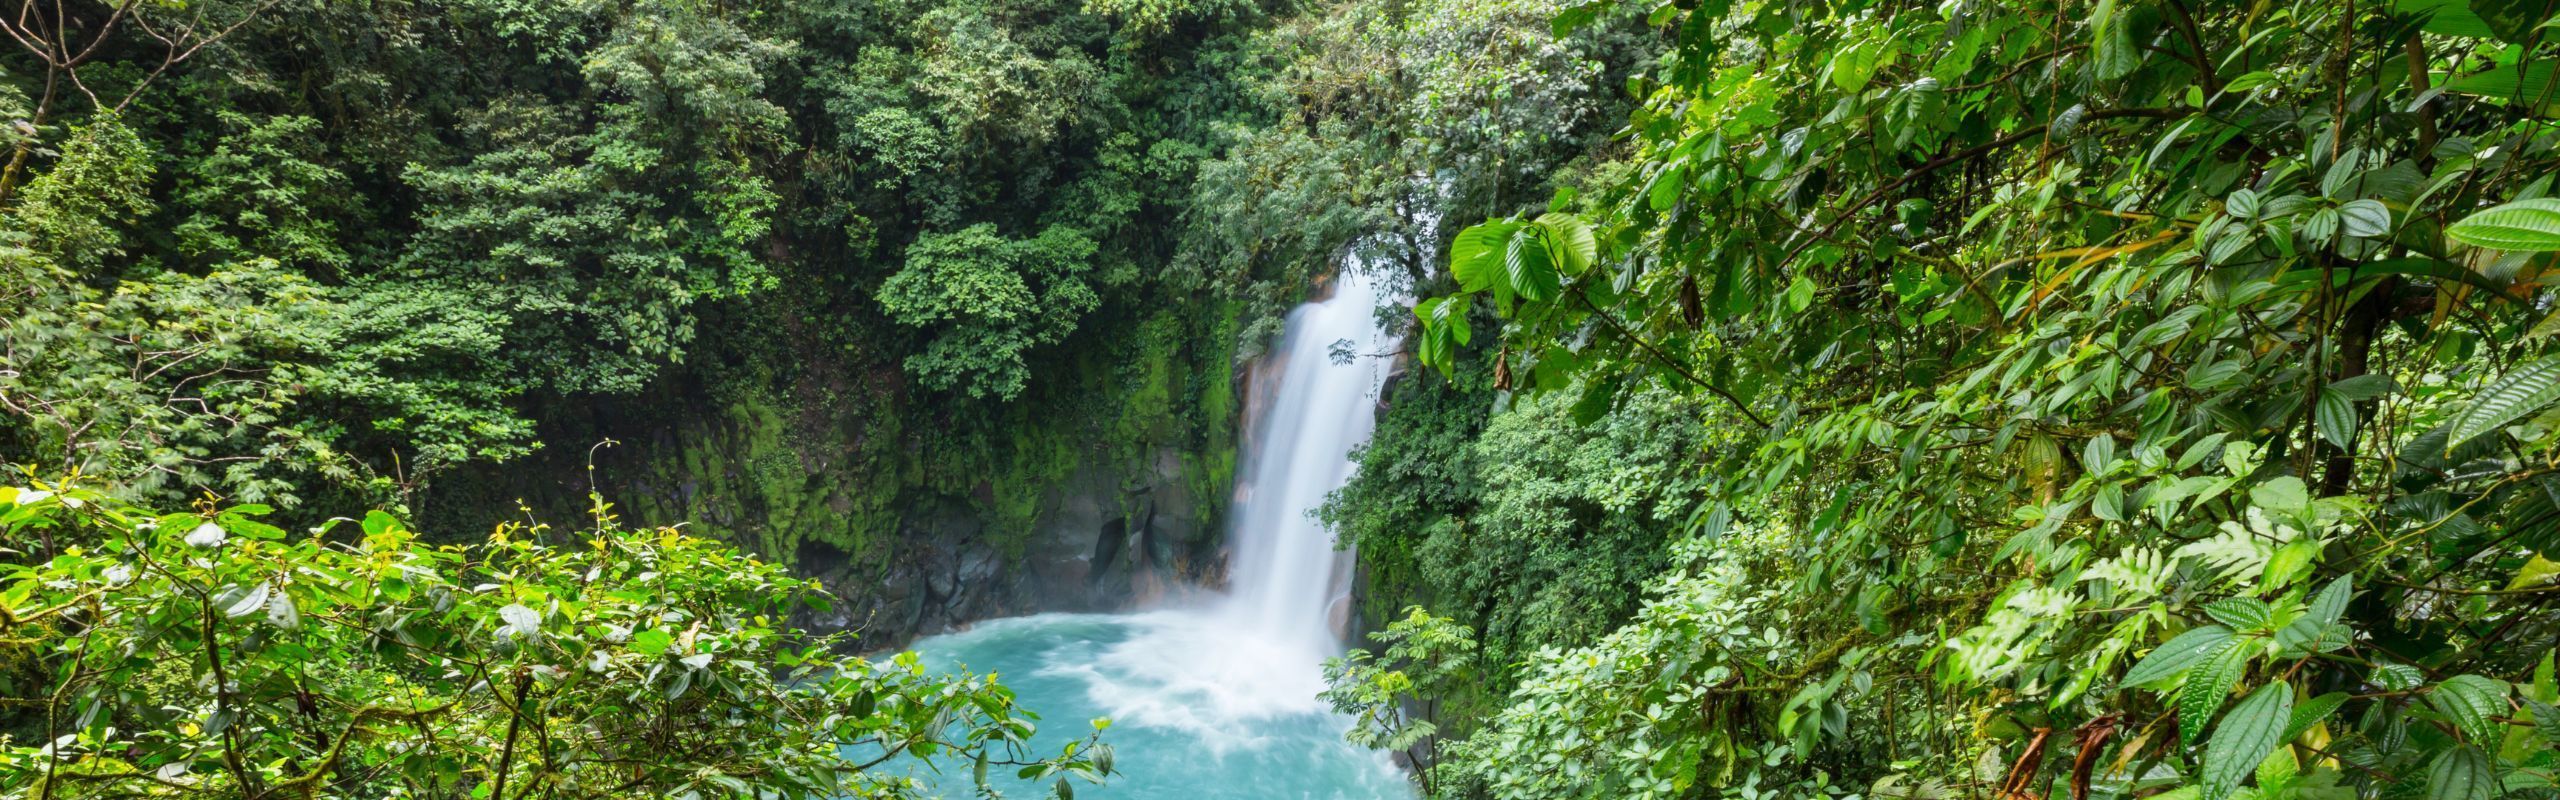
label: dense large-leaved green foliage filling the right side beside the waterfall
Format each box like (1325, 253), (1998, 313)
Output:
(1334, 0), (2560, 800)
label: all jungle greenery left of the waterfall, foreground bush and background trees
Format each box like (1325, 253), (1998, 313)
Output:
(0, 0), (1667, 800)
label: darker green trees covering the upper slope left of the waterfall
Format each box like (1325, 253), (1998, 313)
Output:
(0, 0), (1300, 518)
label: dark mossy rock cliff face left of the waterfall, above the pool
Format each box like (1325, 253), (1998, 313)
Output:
(422, 315), (1236, 649)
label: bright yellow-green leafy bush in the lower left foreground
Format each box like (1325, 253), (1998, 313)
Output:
(0, 476), (1111, 800)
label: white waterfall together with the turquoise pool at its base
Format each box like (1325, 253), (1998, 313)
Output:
(916, 269), (1411, 800)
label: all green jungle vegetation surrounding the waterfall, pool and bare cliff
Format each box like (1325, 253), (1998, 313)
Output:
(0, 0), (2560, 800)
